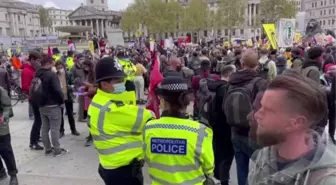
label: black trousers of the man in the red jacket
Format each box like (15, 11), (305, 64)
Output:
(29, 101), (42, 144)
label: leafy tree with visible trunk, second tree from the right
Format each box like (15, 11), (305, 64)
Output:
(217, 0), (247, 40)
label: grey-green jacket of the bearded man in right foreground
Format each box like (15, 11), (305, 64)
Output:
(248, 134), (336, 185)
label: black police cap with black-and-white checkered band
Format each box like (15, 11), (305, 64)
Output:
(157, 76), (188, 95)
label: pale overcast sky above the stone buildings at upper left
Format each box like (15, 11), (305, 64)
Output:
(20, 0), (133, 10)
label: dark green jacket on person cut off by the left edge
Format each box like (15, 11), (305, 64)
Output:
(0, 87), (13, 136)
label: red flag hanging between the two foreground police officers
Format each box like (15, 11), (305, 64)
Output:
(146, 55), (163, 118)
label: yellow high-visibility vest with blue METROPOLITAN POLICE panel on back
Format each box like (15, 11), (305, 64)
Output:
(143, 117), (214, 185)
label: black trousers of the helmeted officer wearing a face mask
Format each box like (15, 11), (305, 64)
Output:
(98, 165), (143, 185)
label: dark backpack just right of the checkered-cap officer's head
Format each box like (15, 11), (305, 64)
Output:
(196, 74), (215, 124)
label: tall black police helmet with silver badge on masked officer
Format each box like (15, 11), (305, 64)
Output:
(95, 57), (126, 83)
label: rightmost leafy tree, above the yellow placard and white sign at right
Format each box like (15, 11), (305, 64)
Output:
(260, 0), (296, 24)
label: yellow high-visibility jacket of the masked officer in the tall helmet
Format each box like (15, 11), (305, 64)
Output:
(88, 89), (153, 169)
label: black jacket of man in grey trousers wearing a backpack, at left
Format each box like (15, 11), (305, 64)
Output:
(35, 68), (64, 106)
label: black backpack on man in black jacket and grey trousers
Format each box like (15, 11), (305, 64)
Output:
(29, 77), (44, 106)
